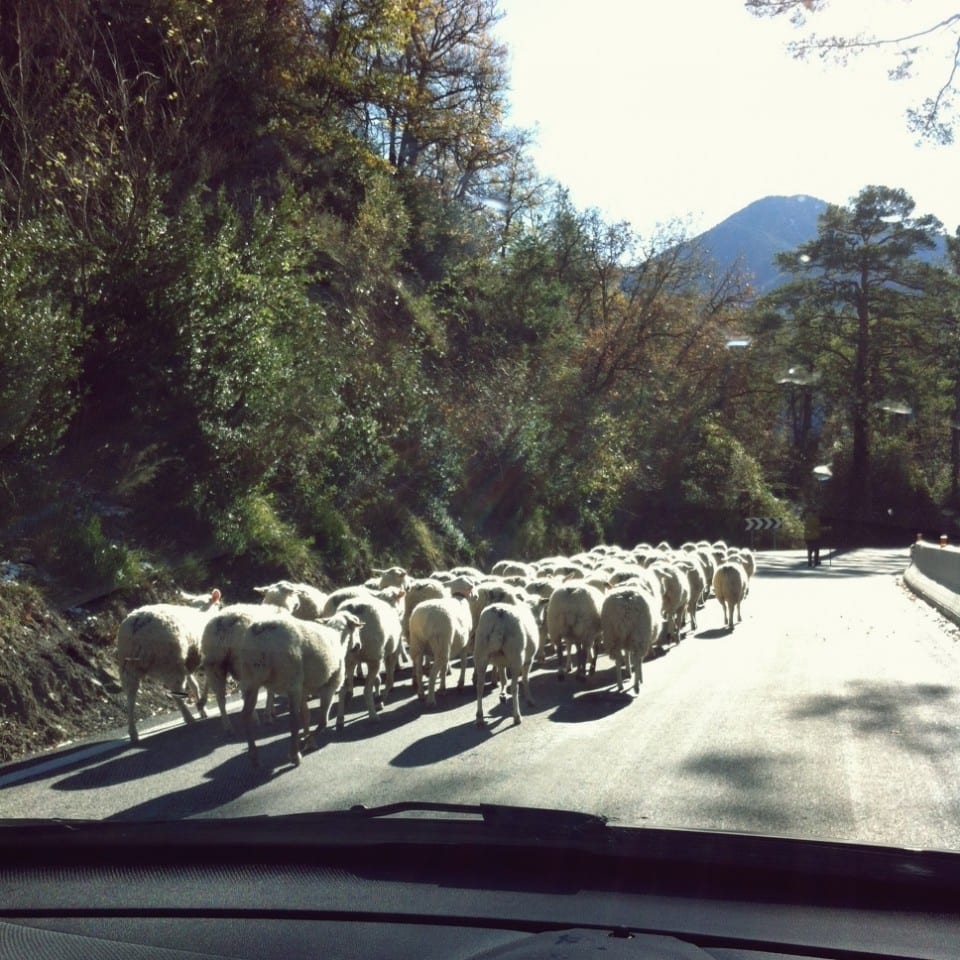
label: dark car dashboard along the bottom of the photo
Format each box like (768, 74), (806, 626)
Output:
(0, 811), (960, 960)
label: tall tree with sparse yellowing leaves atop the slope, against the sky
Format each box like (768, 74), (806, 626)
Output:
(312, 0), (517, 199)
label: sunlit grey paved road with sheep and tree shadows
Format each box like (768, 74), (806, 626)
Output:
(0, 550), (960, 849)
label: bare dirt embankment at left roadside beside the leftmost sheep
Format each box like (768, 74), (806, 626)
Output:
(0, 579), (191, 762)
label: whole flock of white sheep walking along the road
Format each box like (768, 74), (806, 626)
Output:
(117, 541), (755, 765)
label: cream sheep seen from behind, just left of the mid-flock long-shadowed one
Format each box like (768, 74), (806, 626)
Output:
(409, 592), (473, 707)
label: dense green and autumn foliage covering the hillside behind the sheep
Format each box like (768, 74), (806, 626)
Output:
(0, 0), (960, 583)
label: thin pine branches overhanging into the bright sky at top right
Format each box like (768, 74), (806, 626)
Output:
(744, 0), (960, 144)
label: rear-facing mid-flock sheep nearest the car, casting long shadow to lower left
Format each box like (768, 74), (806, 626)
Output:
(473, 600), (540, 728)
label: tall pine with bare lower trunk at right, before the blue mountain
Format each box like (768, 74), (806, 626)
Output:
(769, 186), (942, 519)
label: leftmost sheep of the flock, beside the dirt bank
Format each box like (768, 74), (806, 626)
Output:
(117, 590), (221, 743)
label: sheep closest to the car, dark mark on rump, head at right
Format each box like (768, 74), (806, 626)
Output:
(233, 612), (362, 766)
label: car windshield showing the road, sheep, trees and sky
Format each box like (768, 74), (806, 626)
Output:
(0, 0), (960, 850)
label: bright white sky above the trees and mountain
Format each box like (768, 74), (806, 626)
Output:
(498, 0), (960, 237)
